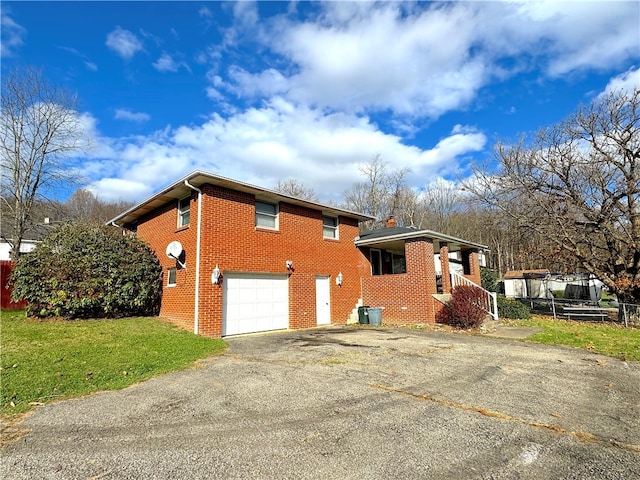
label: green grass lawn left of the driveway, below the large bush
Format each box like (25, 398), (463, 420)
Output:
(0, 311), (226, 416)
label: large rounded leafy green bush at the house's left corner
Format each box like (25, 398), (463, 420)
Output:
(11, 222), (162, 318)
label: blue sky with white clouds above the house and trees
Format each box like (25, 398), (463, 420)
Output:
(1, 1), (640, 202)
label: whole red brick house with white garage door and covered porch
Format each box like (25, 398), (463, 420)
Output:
(109, 171), (485, 337)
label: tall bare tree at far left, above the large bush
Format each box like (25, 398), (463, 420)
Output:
(0, 68), (83, 258)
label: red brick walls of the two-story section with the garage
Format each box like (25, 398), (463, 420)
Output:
(132, 185), (369, 337)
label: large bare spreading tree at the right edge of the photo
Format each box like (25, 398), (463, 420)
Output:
(465, 88), (640, 303)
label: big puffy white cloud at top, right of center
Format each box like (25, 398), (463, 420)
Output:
(273, 2), (489, 118)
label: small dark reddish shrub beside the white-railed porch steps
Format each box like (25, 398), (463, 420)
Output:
(436, 285), (488, 328)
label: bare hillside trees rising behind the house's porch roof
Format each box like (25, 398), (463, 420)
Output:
(343, 155), (548, 275)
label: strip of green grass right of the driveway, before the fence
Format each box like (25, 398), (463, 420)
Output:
(509, 317), (640, 362)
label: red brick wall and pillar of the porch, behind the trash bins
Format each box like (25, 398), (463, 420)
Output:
(362, 239), (437, 325)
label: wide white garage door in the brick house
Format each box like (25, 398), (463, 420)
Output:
(222, 273), (289, 335)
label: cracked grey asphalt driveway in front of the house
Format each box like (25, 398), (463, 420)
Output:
(0, 328), (640, 480)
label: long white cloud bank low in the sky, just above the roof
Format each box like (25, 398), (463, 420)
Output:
(89, 98), (486, 205)
